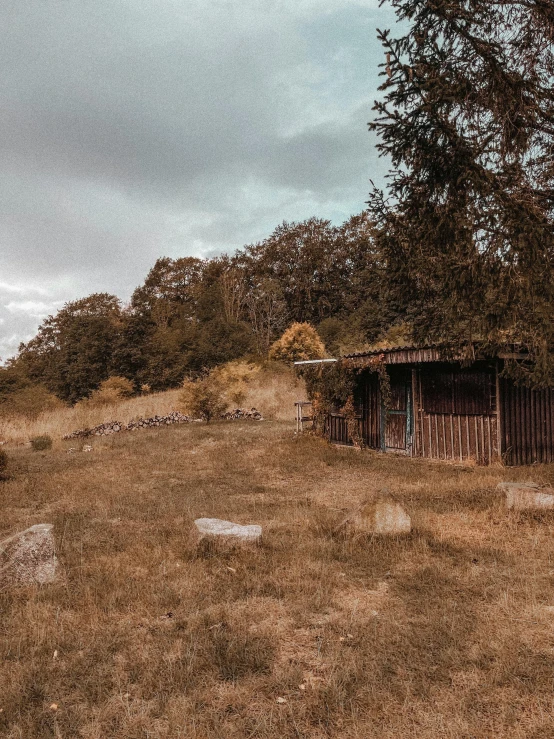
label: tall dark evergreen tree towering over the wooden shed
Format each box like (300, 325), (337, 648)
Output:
(370, 0), (554, 383)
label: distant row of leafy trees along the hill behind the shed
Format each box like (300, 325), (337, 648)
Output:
(0, 212), (396, 403)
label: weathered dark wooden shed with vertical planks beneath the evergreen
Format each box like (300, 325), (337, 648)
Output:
(326, 347), (554, 465)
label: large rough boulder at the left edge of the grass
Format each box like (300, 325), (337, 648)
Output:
(0, 523), (57, 585)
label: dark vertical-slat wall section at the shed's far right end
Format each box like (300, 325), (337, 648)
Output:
(499, 378), (554, 465)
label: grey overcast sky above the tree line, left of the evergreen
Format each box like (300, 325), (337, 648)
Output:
(0, 0), (394, 359)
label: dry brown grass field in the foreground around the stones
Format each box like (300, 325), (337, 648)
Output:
(0, 421), (554, 739)
